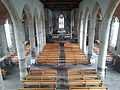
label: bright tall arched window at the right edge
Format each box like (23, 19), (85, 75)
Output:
(110, 17), (119, 47)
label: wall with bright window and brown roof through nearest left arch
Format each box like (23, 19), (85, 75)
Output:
(0, 1), (16, 57)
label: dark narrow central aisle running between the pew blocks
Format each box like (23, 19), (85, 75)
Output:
(57, 42), (69, 90)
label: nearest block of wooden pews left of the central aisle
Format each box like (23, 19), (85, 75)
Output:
(19, 68), (57, 90)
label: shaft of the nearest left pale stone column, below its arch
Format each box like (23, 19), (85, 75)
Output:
(14, 20), (27, 80)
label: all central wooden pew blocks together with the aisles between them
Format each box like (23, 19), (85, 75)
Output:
(19, 42), (107, 90)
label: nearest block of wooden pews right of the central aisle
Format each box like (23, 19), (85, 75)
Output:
(68, 69), (103, 90)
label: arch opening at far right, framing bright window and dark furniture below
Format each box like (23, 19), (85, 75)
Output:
(105, 2), (120, 72)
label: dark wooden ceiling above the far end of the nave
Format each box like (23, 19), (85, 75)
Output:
(40, 0), (82, 10)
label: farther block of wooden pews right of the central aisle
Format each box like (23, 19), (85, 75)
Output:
(64, 44), (89, 64)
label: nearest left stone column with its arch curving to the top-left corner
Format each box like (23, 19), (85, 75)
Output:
(1, 0), (26, 80)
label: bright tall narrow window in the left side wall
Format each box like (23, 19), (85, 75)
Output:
(4, 19), (12, 48)
